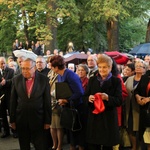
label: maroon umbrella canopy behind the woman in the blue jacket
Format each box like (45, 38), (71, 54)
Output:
(64, 52), (88, 65)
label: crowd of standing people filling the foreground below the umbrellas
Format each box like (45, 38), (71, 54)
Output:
(0, 49), (150, 150)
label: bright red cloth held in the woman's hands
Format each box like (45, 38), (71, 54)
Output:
(92, 93), (105, 114)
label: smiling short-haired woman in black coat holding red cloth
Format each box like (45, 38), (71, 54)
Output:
(85, 54), (122, 150)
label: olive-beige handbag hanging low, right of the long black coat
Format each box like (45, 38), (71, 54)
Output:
(119, 127), (131, 147)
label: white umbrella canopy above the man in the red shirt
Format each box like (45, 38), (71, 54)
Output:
(13, 49), (37, 61)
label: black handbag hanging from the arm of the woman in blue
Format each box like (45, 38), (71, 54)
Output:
(60, 107), (82, 131)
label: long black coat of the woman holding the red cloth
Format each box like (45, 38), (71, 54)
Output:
(85, 76), (122, 146)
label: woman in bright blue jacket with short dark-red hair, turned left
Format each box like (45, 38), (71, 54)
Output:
(50, 55), (85, 150)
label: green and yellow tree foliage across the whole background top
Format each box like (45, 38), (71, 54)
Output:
(0, 0), (150, 52)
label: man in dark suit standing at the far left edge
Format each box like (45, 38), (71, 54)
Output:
(0, 57), (14, 138)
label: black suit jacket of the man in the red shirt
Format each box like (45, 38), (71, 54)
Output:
(10, 72), (51, 130)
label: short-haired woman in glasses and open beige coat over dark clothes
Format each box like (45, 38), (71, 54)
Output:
(124, 60), (147, 150)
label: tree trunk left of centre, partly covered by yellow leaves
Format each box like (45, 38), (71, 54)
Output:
(46, 0), (57, 53)
